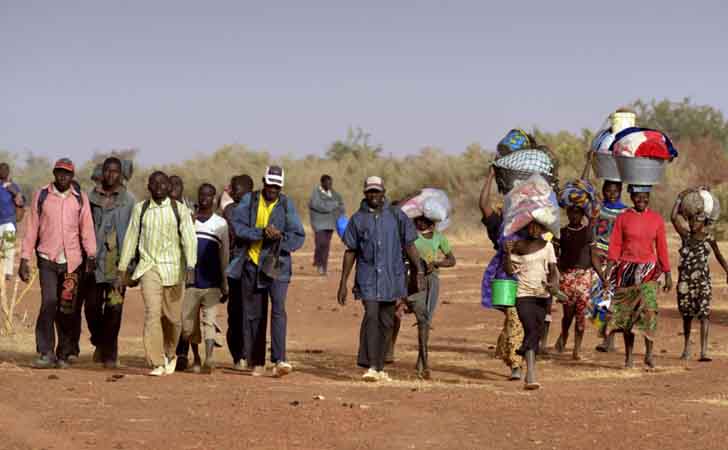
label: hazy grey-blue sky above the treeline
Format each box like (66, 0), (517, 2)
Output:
(0, 0), (728, 163)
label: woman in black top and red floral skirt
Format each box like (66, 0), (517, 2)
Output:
(556, 180), (600, 360)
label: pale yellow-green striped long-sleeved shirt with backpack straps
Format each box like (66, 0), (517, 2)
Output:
(119, 198), (197, 286)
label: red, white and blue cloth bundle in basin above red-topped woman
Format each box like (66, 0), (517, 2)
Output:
(610, 127), (678, 161)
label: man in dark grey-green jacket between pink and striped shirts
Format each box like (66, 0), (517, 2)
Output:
(80, 156), (136, 369)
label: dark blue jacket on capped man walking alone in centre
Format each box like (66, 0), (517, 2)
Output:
(344, 201), (417, 302)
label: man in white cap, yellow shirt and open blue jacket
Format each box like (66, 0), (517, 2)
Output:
(228, 166), (305, 377)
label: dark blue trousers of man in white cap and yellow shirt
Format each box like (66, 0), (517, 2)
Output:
(240, 261), (288, 367)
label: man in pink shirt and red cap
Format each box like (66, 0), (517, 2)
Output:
(18, 158), (96, 369)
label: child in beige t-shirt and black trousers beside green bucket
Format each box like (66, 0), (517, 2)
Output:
(503, 221), (559, 390)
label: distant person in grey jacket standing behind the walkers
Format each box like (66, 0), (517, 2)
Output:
(308, 175), (345, 276)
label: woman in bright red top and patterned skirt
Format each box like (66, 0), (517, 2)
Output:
(606, 185), (672, 368)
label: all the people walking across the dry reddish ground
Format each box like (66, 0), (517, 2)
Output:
(0, 149), (728, 389)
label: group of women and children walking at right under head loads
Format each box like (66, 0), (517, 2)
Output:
(480, 163), (728, 389)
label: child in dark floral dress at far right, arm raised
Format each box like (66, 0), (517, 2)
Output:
(671, 189), (728, 362)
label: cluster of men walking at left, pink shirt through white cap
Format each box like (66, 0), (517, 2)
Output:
(16, 157), (305, 376)
